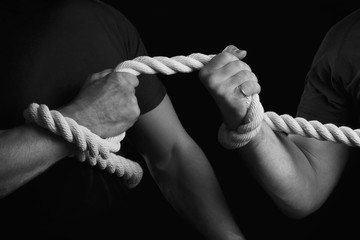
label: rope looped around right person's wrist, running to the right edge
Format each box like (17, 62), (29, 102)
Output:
(218, 91), (360, 149)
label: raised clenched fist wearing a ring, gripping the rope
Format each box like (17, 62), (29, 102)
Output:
(199, 45), (261, 130)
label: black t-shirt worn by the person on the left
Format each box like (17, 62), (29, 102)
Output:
(0, 0), (165, 238)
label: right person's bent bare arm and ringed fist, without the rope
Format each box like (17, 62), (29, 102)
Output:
(200, 46), (350, 218)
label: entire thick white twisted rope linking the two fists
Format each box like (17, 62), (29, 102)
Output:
(24, 53), (360, 187)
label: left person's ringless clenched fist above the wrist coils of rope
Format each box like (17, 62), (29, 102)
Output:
(59, 69), (140, 138)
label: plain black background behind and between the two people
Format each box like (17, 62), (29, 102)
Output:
(104, 0), (360, 239)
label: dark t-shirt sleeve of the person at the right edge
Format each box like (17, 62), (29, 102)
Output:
(297, 9), (360, 126)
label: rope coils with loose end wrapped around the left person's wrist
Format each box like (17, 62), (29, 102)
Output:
(24, 103), (143, 187)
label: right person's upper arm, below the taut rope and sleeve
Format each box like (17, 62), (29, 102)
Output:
(289, 135), (350, 204)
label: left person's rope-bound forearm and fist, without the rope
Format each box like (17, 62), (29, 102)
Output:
(0, 70), (140, 197)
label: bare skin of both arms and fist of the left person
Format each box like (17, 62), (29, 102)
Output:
(0, 62), (244, 240)
